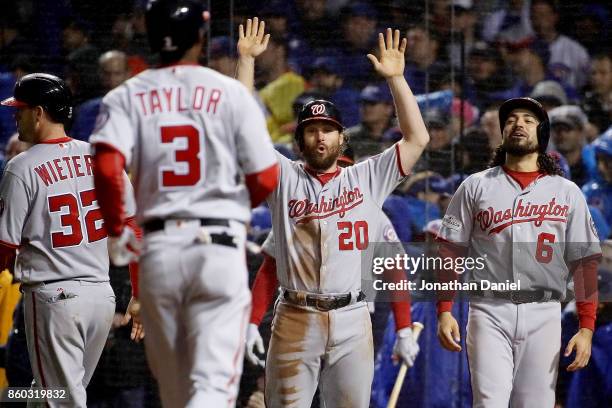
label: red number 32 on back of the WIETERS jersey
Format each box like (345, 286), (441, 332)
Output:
(48, 190), (106, 248)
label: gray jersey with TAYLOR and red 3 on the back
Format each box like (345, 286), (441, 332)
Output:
(90, 65), (276, 224)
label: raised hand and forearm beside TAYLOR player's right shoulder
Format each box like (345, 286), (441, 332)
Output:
(236, 17), (270, 91)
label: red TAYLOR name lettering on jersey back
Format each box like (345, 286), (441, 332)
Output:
(135, 85), (222, 116)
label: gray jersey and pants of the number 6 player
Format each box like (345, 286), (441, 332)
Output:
(439, 167), (601, 408)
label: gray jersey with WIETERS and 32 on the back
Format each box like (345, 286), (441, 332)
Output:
(0, 138), (134, 284)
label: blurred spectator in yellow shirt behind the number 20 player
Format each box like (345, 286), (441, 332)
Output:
(255, 37), (306, 143)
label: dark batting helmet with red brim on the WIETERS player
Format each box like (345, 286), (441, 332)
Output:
(0, 73), (72, 126)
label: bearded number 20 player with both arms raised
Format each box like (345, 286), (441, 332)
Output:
(238, 25), (429, 408)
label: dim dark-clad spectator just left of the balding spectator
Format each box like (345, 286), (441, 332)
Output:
(62, 18), (100, 105)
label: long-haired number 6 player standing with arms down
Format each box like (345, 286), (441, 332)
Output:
(438, 98), (601, 408)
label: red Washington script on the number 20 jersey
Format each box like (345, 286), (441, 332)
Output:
(288, 187), (363, 224)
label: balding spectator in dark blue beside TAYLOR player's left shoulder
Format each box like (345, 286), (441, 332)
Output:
(70, 50), (130, 141)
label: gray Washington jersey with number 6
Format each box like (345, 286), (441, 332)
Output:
(439, 167), (601, 295)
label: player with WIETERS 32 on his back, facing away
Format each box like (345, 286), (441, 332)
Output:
(0, 73), (139, 407)
